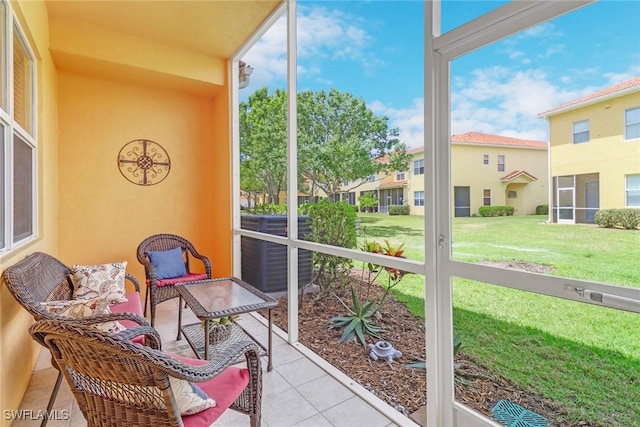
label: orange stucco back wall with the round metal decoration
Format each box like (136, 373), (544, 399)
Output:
(58, 72), (231, 279)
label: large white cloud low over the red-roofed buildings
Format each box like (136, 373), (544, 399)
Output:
(368, 67), (640, 147)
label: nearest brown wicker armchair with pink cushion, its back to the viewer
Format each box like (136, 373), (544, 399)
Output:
(30, 320), (262, 427)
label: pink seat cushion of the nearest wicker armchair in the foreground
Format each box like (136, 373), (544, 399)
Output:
(170, 354), (249, 427)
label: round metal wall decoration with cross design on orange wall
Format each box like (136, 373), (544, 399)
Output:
(118, 139), (171, 185)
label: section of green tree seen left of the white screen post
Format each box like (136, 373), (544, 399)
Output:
(240, 87), (287, 204)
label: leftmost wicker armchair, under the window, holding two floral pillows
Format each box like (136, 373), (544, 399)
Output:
(2, 252), (148, 427)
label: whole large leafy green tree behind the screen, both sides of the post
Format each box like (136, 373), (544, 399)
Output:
(240, 87), (409, 203)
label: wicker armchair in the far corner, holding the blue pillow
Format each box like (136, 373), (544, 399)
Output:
(136, 234), (211, 326)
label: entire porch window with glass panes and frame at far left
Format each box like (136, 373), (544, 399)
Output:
(0, 9), (37, 253)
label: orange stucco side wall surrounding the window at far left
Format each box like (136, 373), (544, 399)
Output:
(0, 1), (58, 427)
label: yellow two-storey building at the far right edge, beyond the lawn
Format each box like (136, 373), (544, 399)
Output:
(540, 77), (640, 224)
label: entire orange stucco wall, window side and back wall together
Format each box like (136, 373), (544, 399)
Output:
(0, 1), (232, 427)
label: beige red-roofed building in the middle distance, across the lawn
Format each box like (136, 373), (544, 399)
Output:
(343, 132), (549, 217)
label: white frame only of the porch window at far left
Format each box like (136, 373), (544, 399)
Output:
(0, 0), (38, 255)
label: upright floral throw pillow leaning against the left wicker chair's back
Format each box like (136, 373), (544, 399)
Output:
(71, 261), (127, 304)
